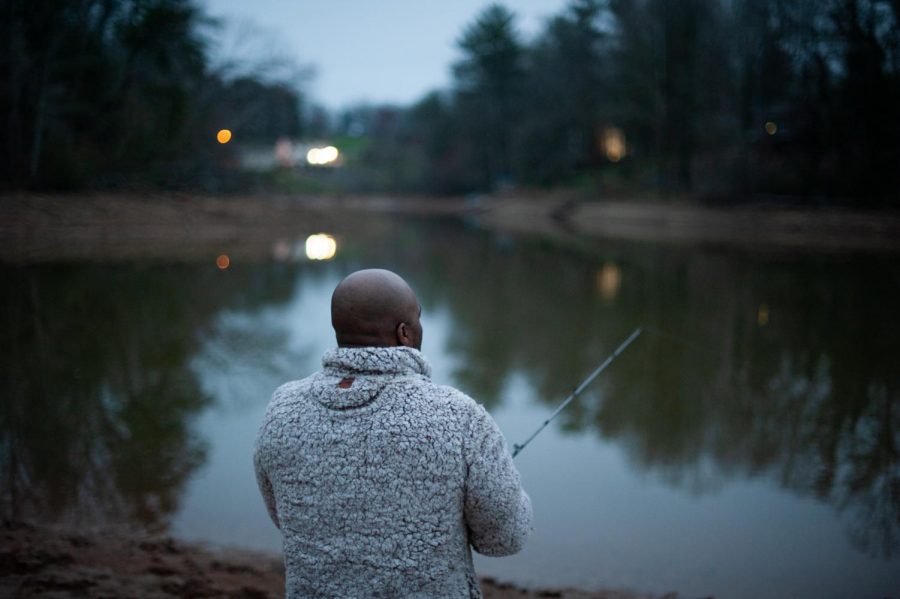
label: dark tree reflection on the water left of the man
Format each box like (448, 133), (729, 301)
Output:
(0, 265), (306, 528)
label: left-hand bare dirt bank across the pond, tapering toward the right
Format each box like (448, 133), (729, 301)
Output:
(0, 194), (463, 262)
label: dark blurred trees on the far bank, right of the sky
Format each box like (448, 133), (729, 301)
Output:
(351, 0), (900, 206)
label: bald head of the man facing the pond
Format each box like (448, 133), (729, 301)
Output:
(331, 269), (422, 349)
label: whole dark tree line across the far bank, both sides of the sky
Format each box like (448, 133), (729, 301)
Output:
(0, 0), (900, 206)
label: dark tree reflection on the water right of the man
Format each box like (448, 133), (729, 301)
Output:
(356, 225), (900, 556)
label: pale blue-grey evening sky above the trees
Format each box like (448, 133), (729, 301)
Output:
(201, 0), (567, 110)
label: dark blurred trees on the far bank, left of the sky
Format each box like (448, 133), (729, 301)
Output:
(0, 0), (302, 189)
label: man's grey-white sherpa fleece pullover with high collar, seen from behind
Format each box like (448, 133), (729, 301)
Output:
(254, 347), (532, 597)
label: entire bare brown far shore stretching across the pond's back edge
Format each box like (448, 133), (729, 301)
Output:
(0, 193), (900, 262)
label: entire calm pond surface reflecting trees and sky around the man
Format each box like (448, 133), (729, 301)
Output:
(0, 221), (900, 597)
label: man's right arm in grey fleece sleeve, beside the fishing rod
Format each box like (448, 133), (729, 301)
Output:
(464, 405), (532, 556)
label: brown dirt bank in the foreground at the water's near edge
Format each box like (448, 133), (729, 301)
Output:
(0, 522), (676, 599)
